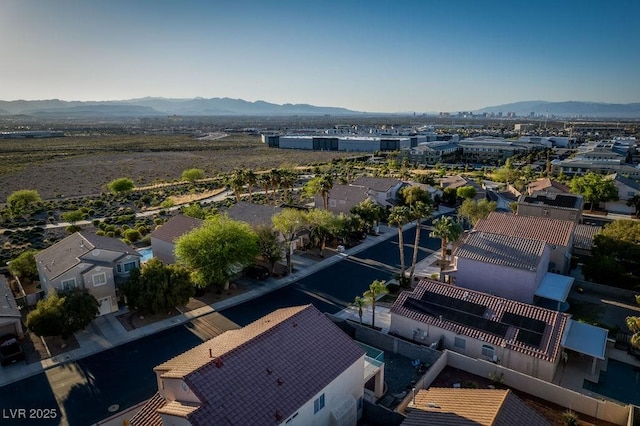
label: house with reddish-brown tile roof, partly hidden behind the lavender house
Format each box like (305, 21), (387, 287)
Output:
(474, 212), (576, 274)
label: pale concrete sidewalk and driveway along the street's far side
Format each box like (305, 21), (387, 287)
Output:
(0, 221), (402, 387)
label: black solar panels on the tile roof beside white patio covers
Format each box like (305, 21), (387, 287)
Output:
(404, 291), (546, 348)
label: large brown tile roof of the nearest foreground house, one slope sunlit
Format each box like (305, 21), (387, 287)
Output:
(154, 305), (364, 425)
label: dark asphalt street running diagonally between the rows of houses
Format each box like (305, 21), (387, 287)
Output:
(0, 228), (440, 425)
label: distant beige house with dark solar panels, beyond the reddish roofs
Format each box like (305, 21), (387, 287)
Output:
(517, 192), (584, 223)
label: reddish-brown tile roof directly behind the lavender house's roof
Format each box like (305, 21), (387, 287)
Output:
(474, 212), (575, 247)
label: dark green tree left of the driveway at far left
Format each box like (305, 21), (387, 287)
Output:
(27, 289), (99, 339)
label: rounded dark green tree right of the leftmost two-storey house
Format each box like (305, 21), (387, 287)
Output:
(122, 258), (195, 314)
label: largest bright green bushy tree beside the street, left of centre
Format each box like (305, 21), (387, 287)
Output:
(175, 215), (258, 289)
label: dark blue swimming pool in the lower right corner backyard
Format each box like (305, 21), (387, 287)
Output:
(582, 359), (640, 405)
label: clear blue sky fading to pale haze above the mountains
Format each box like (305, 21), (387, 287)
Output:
(0, 0), (640, 112)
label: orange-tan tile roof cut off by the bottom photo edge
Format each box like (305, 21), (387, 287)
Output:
(402, 388), (551, 426)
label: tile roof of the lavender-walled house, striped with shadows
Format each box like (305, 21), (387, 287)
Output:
(453, 231), (546, 271)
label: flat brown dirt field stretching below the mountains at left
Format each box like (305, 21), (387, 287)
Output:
(0, 135), (353, 201)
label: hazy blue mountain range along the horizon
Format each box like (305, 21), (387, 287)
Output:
(0, 97), (640, 119)
